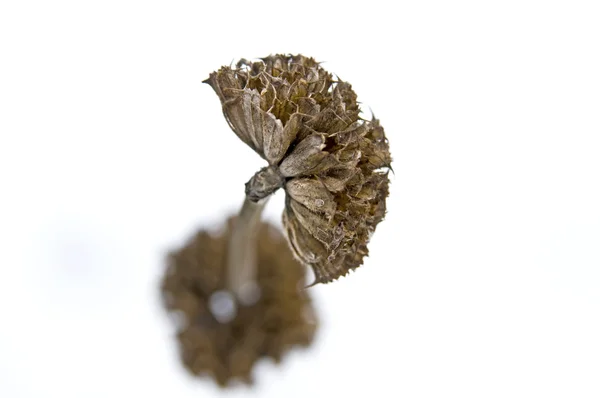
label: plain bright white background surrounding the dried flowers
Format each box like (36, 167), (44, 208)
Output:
(0, 0), (600, 398)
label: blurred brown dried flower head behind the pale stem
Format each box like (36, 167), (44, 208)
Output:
(162, 218), (317, 386)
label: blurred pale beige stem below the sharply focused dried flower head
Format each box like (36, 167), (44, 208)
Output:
(227, 197), (269, 305)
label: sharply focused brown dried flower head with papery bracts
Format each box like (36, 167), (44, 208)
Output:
(206, 55), (391, 283)
